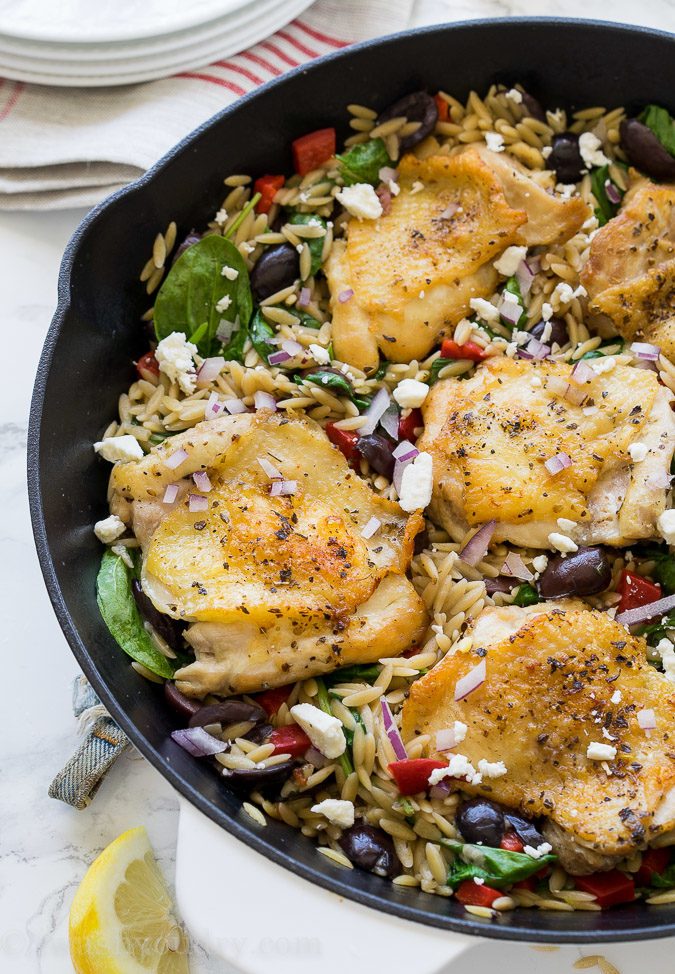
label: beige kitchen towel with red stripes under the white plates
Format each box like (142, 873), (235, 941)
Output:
(0, 0), (414, 210)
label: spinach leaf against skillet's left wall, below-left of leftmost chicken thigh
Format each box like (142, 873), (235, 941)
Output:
(96, 549), (174, 680)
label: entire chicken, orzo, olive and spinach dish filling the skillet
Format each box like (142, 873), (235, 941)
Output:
(94, 85), (675, 919)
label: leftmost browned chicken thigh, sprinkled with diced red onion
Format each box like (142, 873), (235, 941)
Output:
(111, 412), (427, 696)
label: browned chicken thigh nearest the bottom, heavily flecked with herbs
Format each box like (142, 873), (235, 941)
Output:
(402, 605), (675, 873)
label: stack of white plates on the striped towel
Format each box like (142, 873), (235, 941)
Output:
(0, 0), (312, 87)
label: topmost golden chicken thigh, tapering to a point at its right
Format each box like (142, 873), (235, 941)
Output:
(325, 146), (589, 370)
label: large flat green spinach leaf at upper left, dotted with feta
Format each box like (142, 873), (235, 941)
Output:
(155, 234), (253, 356)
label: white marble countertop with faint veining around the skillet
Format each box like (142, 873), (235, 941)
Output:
(0, 0), (675, 974)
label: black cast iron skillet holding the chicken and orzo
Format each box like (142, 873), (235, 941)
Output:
(28, 19), (675, 943)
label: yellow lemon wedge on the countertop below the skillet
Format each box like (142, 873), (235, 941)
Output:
(69, 827), (188, 974)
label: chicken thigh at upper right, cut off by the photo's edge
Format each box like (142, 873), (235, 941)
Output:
(581, 179), (675, 359)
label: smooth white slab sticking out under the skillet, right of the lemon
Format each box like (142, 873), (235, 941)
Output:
(176, 798), (477, 974)
